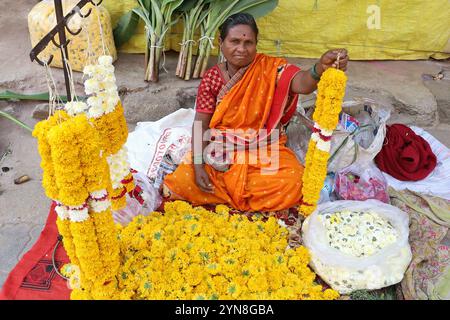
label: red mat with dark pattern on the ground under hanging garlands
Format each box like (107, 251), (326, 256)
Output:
(0, 205), (70, 300)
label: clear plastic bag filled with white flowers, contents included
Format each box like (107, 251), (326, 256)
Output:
(302, 200), (412, 294)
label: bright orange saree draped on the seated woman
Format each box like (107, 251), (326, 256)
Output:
(164, 54), (303, 211)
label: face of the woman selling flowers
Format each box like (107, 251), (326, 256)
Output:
(220, 24), (256, 68)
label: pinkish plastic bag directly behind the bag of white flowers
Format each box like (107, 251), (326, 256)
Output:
(335, 162), (389, 203)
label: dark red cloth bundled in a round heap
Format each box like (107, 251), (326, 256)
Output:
(375, 124), (436, 181)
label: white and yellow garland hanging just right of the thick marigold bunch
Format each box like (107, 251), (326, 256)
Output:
(84, 55), (135, 210)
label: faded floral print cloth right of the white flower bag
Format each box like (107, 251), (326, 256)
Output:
(389, 188), (450, 300)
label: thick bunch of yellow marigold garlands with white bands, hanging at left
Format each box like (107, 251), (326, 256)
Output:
(33, 111), (120, 299)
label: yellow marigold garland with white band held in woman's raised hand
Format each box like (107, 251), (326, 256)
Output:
(300, 68), (347, 216)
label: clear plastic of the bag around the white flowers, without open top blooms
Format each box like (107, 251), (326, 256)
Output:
(302, 200), (412, 294)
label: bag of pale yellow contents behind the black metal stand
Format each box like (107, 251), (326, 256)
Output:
(28, 0), (117, 71)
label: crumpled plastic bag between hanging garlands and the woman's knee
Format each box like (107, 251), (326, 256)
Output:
(113, 172), (162, 226)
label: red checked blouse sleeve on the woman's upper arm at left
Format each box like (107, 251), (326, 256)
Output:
(195, 67), (224, 114)
